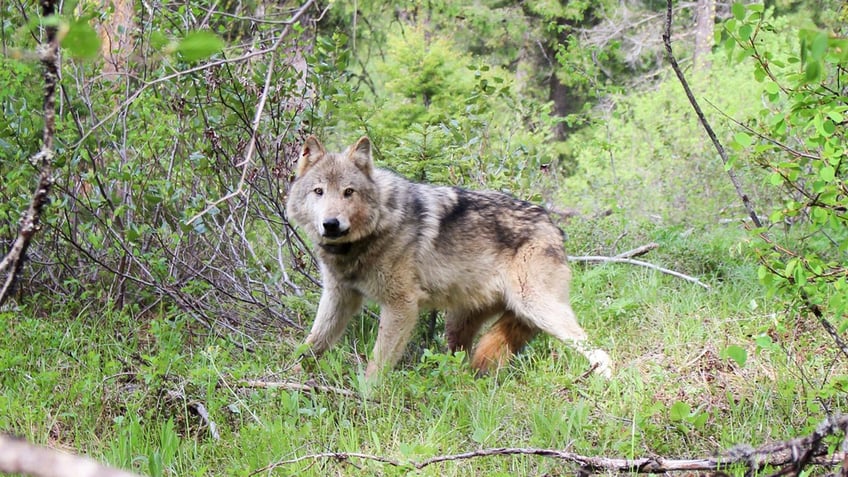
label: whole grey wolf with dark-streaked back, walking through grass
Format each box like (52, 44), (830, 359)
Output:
(286, 136), (611, 379)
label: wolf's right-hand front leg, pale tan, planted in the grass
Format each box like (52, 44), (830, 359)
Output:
(365, 303), (418, 380)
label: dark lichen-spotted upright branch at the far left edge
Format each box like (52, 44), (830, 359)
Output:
(0, 0), (59, 306)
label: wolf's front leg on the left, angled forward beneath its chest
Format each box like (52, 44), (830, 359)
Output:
(306, 282), (362, 355)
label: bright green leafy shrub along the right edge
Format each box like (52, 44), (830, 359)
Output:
(724, 4), (848, 358)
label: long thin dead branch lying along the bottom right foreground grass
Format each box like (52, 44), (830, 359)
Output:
(250, 416), (848, 475)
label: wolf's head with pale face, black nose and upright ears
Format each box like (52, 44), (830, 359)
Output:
(286, 136), (380, 246)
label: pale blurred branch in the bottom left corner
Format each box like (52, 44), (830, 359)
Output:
(0, 434), (139, 477)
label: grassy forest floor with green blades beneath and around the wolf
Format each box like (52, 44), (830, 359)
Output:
(0, 221), (845, 476)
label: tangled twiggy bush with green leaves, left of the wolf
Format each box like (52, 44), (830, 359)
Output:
(0, 4), (322, 327)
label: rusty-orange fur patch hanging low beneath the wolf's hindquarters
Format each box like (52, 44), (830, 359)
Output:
(471, 311), (537, 374)
